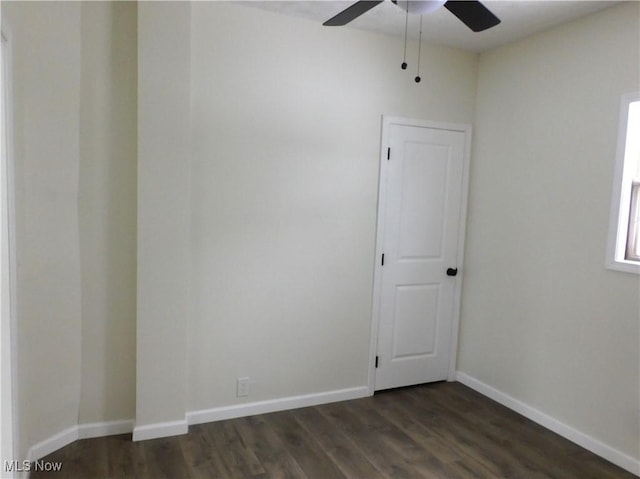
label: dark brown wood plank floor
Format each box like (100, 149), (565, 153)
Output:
(31, 383), (635, 479)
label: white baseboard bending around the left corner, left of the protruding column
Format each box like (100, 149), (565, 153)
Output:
(27, 419), (133, 462)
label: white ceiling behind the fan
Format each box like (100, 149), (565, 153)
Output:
(242, 0), (624, 52)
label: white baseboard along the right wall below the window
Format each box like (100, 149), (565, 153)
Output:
(456, 371), (640, 476)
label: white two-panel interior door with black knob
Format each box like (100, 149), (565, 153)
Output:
(375, 119), (470, 390)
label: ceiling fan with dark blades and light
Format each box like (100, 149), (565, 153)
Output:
(323, 0), (500, 32)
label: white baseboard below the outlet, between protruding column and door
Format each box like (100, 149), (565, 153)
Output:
(187, 386), (371, 424)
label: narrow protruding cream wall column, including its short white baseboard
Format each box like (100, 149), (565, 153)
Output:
(134, 2), (191, 440)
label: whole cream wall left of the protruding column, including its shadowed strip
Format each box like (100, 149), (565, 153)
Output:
(2, 2), (137, 460)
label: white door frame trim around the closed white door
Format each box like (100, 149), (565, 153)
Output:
(368, 115), (472, 395)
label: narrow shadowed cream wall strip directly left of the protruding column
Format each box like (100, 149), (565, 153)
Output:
(78, 2), (138, 423)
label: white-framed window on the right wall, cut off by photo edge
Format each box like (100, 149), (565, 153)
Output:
(607, 93), (640, 273)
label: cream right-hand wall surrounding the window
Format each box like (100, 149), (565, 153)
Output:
(459, 2), (640, 460)
